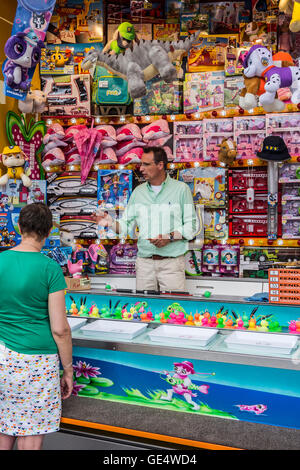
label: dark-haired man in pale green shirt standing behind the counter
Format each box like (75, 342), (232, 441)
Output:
(96, 147), (198, 291)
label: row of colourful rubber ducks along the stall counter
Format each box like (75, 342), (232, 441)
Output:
(67, 297), (300, 333)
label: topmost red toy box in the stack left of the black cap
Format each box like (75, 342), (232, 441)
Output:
(228, 168), (268, 191)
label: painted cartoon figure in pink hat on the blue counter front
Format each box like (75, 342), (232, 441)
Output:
(160, 361), (209, 410)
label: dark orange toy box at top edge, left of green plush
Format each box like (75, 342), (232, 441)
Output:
(47, 0), (103, 44)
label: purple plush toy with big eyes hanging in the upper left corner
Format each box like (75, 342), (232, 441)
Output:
(3, 31), (45, 91)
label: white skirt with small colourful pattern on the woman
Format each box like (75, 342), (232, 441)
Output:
(0, 348), (61, 436)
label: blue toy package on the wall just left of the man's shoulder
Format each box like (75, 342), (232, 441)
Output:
(97, 170), (132, 210)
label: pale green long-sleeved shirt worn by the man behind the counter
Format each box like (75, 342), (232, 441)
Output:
(119, 175), (197, 258)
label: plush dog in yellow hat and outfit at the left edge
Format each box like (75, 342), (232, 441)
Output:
(0, 146), (32, 188)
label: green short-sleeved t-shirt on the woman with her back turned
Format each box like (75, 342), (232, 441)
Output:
(0, 250), (66, 354)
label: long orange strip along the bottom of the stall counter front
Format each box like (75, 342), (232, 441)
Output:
(61, 418), (243, 450)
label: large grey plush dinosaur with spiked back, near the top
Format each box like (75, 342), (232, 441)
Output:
(81, 32), (199, 99)
